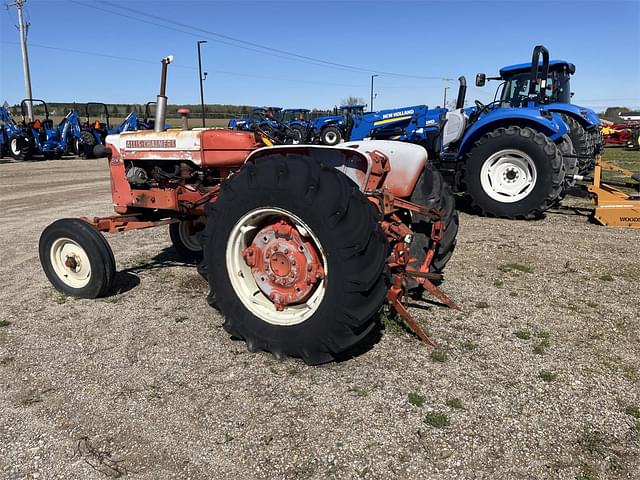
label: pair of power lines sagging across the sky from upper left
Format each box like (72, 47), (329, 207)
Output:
(72, 0), (452, 80)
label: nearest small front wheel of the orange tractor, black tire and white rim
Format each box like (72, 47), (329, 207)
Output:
(39, 218), (116, 298)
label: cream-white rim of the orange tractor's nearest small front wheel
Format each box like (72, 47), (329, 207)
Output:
(49, 238), (91, 288)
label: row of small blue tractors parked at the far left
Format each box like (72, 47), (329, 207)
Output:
(0, 98), (162, 160)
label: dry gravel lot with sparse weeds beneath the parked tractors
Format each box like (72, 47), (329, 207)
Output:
(0, 150), (640, 479)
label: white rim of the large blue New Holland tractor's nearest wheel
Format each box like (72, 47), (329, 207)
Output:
(480, 150), (538, 203)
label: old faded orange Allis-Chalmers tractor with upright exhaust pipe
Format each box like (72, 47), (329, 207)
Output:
(39, 57), (458, 364)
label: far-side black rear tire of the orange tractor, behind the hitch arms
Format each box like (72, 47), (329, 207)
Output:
(410, 164), (459, 287)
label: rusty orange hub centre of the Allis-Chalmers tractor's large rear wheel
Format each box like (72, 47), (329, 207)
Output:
(242, 218), (324, 311)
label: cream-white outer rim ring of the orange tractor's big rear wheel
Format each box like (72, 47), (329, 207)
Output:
(225, 207), (328, 326)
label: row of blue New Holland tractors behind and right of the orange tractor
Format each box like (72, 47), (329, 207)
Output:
(229, 46), (624, 218)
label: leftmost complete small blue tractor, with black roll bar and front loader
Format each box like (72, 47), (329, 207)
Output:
(9, 98), (80, 160)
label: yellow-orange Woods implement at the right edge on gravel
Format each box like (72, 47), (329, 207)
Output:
(585, 157), (640, 228)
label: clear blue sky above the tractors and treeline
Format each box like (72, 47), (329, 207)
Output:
(0, 0), (640, 110)
